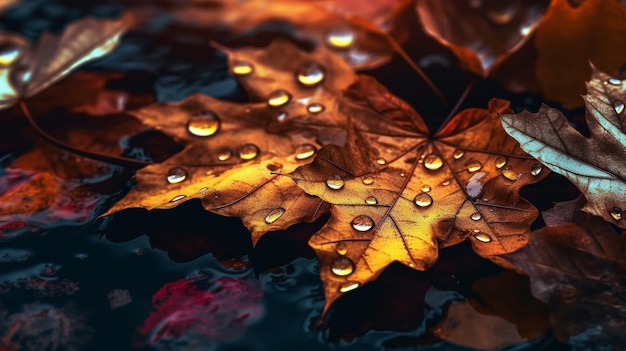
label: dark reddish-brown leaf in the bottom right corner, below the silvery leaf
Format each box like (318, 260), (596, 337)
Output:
(503, 197), (626, 348)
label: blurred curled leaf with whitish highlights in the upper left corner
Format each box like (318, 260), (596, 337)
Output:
(0, 14), (135, 109)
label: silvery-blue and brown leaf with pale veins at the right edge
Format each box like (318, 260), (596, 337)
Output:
(502, 68), (626, 228)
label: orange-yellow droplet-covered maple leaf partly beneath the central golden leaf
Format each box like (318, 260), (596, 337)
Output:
(103, 41), (414, 242)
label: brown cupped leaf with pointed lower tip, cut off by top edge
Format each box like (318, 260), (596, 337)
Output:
(417, 0), (548, 76)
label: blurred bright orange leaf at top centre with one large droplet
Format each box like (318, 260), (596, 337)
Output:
(176, 0), (411, 69)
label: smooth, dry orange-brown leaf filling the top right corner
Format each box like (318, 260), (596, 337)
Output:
(534, 0), (626, 108)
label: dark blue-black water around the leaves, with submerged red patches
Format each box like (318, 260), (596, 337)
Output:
(0, 0), (566, 351)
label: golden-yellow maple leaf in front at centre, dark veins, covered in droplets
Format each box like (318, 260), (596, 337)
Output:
(291, 78), (547, 311)
